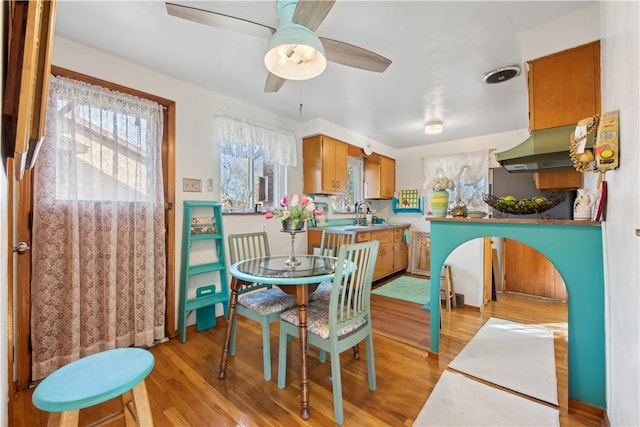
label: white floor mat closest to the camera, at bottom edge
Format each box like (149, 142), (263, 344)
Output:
(413, 371), (560, 427)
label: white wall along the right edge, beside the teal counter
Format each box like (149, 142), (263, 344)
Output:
(594, 1), (640, 426)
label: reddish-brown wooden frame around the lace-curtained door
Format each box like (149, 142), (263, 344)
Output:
(9, 66), (176, 391)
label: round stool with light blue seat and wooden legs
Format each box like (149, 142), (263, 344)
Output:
(32, 348), (154, 427)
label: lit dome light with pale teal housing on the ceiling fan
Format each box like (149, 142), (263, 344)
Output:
(264, 23), (327, 80)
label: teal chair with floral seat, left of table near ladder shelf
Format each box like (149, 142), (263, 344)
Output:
(228, 231), (298, 381)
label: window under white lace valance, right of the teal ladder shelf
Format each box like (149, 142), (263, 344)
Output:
(220, 140), (286, 212)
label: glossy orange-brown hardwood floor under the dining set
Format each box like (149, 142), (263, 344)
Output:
(9, 276), (600, 427)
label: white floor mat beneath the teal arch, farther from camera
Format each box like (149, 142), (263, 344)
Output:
(449, 317), (558, 405)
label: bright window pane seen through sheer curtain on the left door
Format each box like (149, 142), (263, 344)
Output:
(55, 100), (156, 201)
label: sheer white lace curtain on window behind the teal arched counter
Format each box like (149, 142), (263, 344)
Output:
(423, 150), (489, 211)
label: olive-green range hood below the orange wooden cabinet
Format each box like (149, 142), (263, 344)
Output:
(496, 125), (576, 172)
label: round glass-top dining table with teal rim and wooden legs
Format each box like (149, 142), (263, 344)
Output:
(219, 255), (352, 420)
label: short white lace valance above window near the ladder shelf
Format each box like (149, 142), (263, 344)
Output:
(215, 116), (298, 167)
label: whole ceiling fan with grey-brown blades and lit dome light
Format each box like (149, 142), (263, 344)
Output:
(166, 0), (391, 92)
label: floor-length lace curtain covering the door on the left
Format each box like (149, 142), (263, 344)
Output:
(31, 77), (166, 380)
